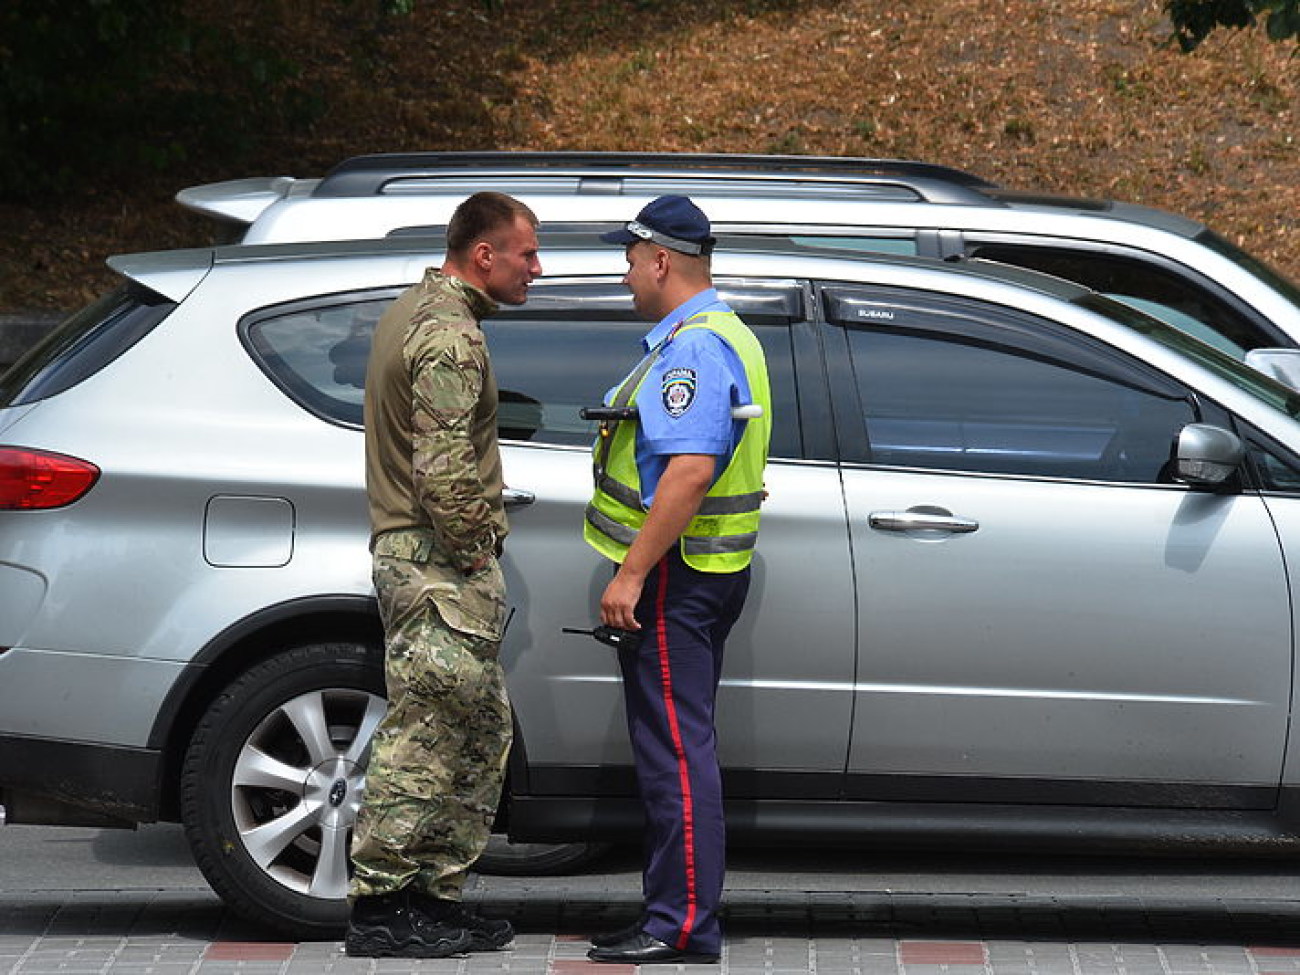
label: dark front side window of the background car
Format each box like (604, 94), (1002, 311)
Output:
(967, 243), (1291, 359)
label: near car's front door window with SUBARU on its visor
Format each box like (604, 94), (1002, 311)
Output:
(831, 289), (1196, 484)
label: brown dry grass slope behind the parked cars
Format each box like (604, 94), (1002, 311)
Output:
(0, 0), (1300, 311)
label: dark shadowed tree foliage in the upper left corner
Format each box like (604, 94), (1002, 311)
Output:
(0, 0), (412, 200)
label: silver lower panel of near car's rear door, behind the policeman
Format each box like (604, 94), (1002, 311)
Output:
(502, 443), (854, 775)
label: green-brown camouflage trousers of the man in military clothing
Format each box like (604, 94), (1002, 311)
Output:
(350, 555), (511, 900)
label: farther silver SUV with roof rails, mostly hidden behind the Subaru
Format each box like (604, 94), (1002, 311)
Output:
(185, 152), (1300, 359)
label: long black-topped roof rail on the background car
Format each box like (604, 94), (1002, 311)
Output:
(312, 152), (996, 205)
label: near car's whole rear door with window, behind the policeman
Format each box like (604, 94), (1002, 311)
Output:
(484, 280), (854, 797)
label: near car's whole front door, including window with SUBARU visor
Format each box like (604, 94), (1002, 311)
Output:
(824, 286), (1291, 807)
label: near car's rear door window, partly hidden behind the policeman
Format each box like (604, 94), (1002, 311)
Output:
(484, 282), (801, 458)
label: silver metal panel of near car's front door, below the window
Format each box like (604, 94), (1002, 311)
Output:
(845, 471), (1292, 800)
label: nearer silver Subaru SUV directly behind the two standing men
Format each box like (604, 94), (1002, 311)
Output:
(0, 231), (1300, 937)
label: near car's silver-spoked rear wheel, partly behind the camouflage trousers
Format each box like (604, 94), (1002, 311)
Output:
(181, 644), (385, 937)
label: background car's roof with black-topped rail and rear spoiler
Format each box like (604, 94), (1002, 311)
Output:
(176, 152), (1204, 252)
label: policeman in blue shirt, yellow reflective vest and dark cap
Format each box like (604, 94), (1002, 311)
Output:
(584, 196), (771, 965)
